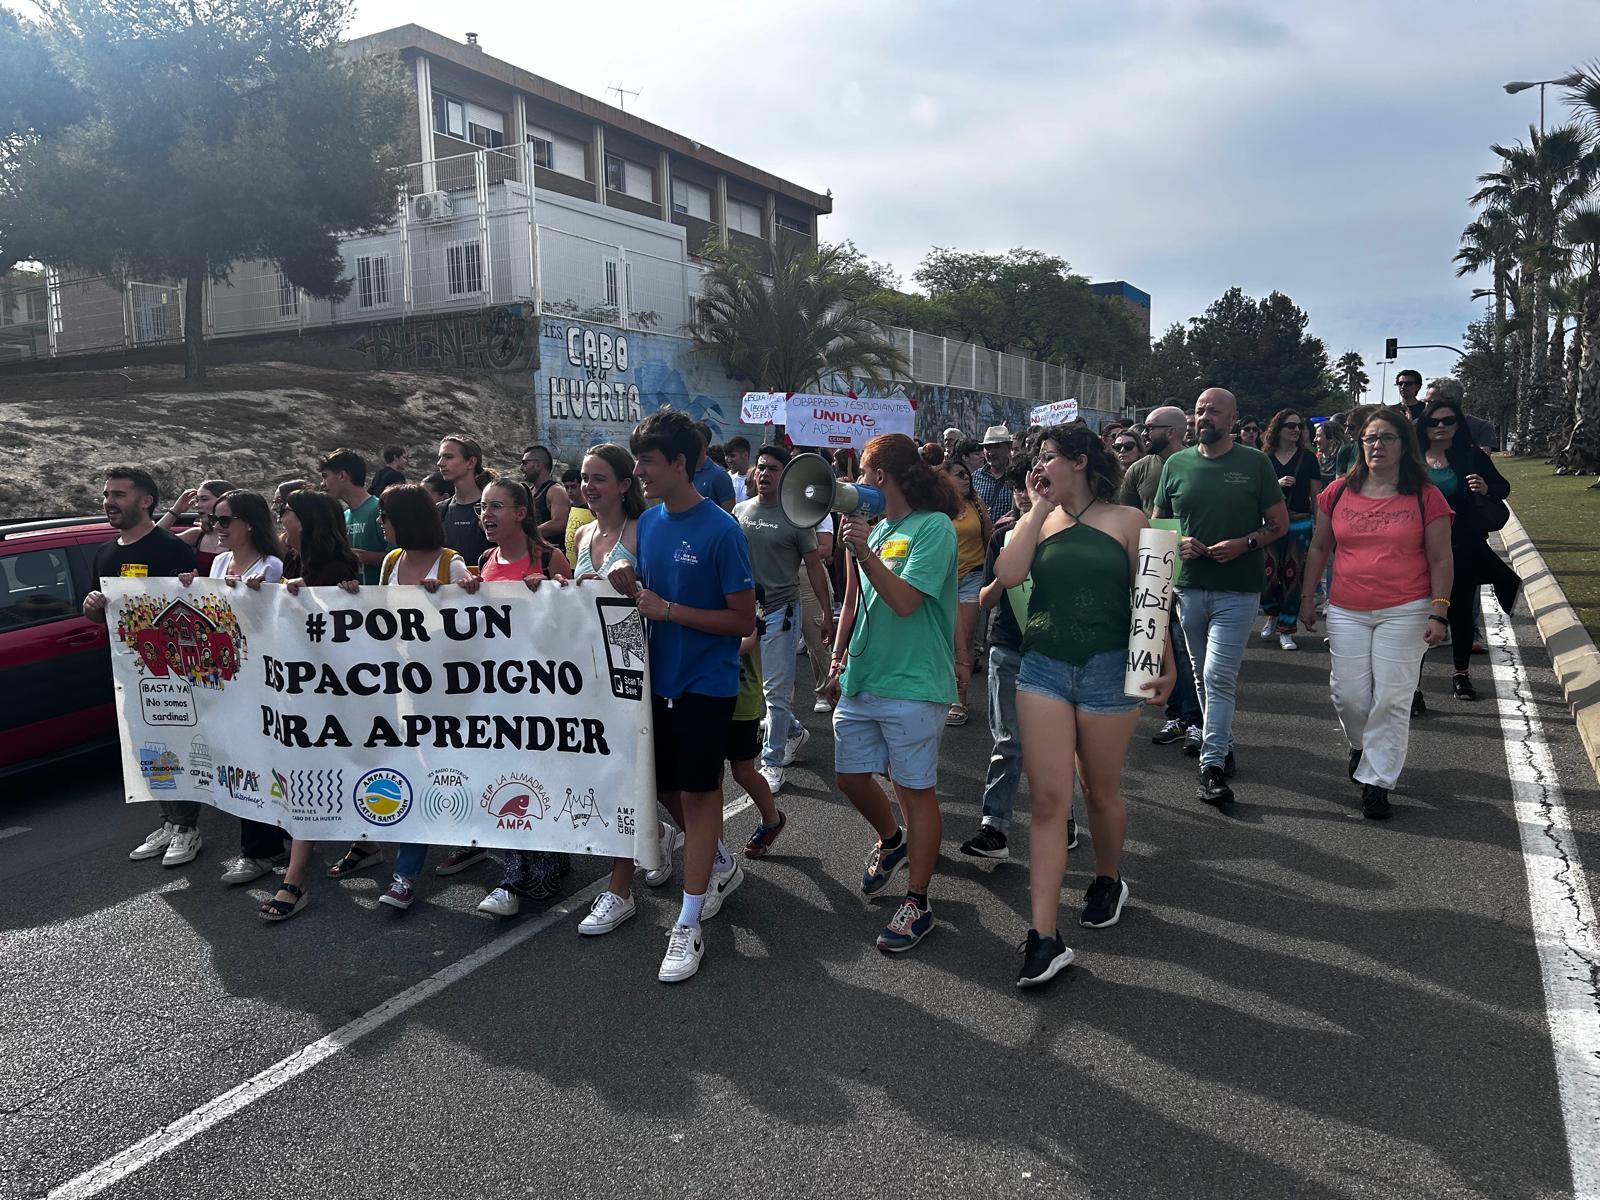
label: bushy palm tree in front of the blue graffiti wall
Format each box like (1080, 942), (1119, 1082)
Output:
(694, 240), (910, 392)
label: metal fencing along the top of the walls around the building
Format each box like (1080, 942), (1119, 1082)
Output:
(0, 150), (1125, 413)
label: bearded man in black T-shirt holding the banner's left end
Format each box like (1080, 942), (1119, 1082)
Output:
(83, 467), (200, 867)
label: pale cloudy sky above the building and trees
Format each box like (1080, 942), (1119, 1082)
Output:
(363, 0), (1600, 382)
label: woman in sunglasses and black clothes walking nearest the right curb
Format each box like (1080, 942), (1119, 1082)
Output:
(1411, 397), (1522, 704)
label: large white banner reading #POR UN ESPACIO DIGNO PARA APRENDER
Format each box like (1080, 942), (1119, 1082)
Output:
(104, 579), (659, 866)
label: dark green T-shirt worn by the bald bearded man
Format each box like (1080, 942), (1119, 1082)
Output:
(1154, 442), (1283, 592)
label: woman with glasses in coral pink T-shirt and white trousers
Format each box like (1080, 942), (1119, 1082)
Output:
(1299, 408), (1454, 821)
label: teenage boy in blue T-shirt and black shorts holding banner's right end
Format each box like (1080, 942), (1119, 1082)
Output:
(592, 413), (755, 984)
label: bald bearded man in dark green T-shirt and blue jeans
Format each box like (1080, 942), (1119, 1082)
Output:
(1154, 387), (1290, 805)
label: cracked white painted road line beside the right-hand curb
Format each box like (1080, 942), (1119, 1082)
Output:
(1483, 598), (1600, 1200)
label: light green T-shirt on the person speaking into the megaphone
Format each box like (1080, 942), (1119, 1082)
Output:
(840, 512), (955, 704)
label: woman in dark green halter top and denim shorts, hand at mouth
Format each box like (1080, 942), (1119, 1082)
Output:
(995, 422), (1178, 987)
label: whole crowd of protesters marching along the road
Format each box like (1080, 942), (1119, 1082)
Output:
(85, 371), (1520, 987)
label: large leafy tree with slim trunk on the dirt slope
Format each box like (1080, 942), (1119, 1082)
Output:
(0, 0), (414, 374)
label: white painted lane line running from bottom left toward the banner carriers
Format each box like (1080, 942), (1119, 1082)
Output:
(48, 797), (752, 1200)
